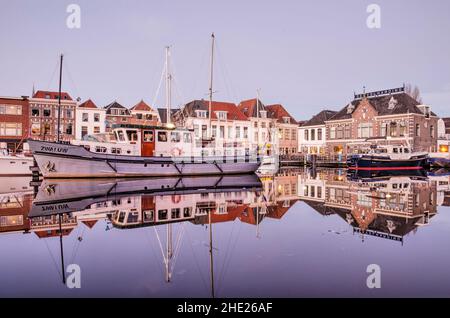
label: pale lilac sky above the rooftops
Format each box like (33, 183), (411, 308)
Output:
(0, 0), (450, 120)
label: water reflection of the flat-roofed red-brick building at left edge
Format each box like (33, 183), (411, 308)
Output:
(0, 192), (33, 233)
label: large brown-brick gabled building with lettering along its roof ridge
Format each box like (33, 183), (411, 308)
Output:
(325, 87), (438, 156)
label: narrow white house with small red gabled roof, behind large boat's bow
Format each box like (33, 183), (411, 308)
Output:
(75, 99), (106, 140)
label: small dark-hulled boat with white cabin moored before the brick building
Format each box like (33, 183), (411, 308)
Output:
(347, 145), (428, 170)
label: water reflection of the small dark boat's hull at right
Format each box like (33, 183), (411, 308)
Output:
(347, 169), (427, 181)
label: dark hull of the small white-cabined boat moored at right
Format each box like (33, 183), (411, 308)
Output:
(347, 155), (428, 171)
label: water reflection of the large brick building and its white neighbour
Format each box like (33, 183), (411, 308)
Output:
(299, 170), (442, 243)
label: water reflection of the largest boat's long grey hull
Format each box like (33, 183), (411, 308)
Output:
(30, 174), (262, 217)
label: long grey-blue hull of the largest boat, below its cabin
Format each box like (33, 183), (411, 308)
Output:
(29, 141), (259, 178)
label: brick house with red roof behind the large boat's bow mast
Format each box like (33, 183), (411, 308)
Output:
(29, 91), (77, 141)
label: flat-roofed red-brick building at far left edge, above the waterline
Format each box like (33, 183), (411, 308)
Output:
(0, 96), (30, 152)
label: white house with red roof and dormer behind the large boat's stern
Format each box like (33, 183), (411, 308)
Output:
(173, 100), (251, 156)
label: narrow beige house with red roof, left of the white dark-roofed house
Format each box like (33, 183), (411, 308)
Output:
(266, 104), (298, 155)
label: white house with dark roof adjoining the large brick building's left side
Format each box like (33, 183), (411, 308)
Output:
(298, 110), (337, 155)
